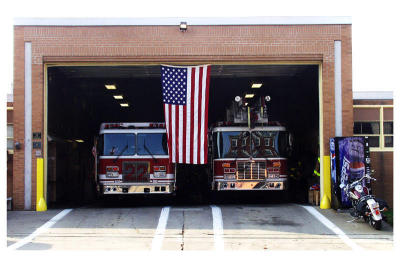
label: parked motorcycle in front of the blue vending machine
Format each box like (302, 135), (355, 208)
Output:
(340, 174), (387, 230)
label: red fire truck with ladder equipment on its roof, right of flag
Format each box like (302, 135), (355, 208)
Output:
(209, 96), (292, 192)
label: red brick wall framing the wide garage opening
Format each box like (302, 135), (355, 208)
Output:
(14, 25), (353, 208)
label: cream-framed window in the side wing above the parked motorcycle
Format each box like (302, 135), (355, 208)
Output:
(353, 105), (393, 151)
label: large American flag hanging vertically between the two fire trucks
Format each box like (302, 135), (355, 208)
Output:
(161, 65), (210, 164)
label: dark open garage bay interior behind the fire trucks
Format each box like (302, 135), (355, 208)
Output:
(47, 64), (319, 207)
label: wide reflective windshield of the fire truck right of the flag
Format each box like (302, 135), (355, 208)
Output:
(213, 131), (288, 158)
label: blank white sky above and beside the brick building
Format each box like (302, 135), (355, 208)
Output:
(0, 0), (400, 91)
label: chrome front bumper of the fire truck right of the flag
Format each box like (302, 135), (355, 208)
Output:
(212, 178), (288, 191)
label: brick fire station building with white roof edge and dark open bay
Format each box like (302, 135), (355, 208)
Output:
(12, 17), (368, 210)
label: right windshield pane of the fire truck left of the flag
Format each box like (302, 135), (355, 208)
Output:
(137, 133), (168, 155)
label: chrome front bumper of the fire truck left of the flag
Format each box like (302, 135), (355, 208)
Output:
(101, 183), (175, 195)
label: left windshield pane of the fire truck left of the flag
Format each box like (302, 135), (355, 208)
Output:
(103, 133), (136, 156)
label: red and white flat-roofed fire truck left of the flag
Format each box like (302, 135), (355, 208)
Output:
(94, 122), (176, 196)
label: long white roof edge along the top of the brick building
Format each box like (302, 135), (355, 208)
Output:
(14, 16), (352, 26)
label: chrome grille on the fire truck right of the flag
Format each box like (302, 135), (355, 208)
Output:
(236, 161), (266, 180)
